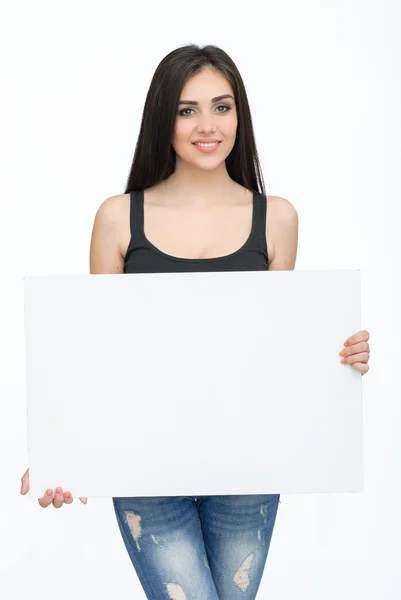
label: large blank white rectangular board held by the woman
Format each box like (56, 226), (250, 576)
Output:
(24, 270), (363, 498)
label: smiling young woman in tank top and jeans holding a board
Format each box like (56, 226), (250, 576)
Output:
(21, 45), (369, 600)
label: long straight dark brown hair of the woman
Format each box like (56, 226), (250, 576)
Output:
(124, 44), (266, 194)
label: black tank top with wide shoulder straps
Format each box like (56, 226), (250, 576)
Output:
(124, 190), (269, 273)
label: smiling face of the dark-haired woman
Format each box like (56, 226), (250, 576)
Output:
(172, 68), (237, 169)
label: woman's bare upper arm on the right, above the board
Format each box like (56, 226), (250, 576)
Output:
(266, 196), (298, 271)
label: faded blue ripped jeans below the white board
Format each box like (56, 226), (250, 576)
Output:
(113, 494), (280, 600)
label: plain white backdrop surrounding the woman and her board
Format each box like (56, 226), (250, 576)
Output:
(0, 0), (401, 600)
